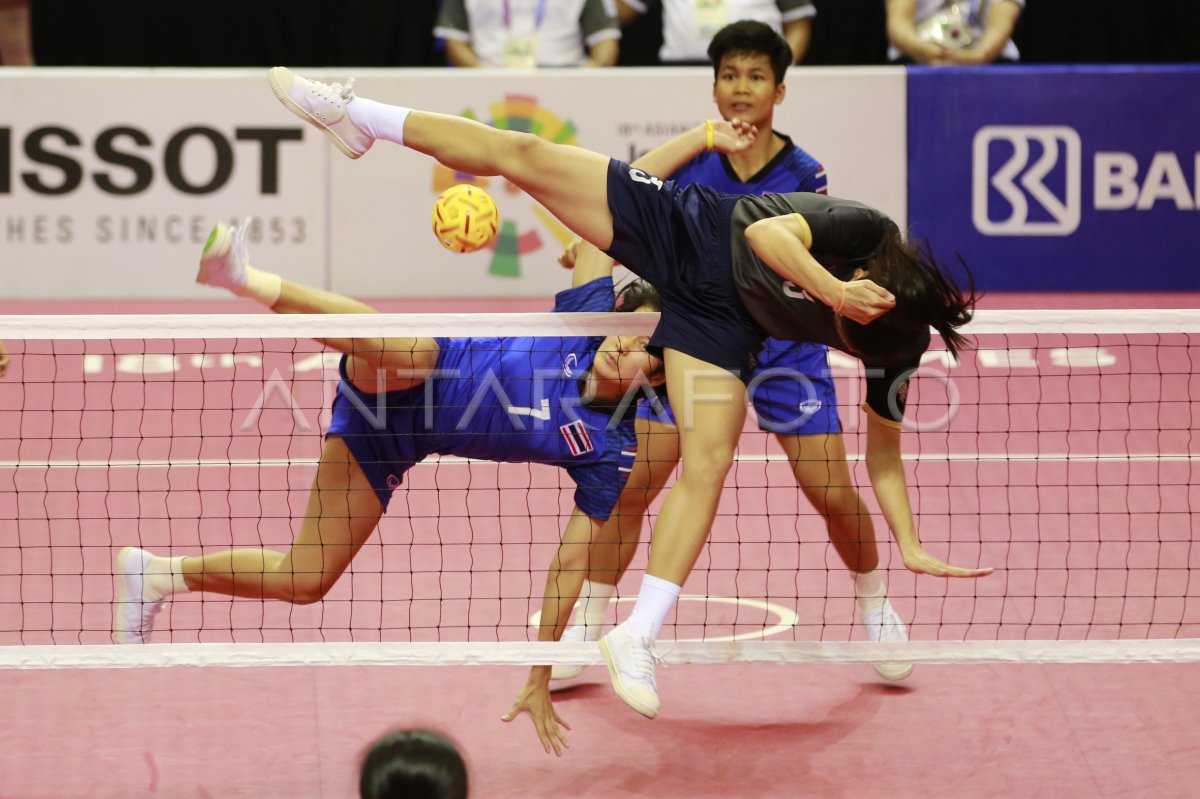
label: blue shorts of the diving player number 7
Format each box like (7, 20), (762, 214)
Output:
(325, 338), (446, 510)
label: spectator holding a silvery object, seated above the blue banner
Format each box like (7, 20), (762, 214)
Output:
(884, 0), (1025, 66)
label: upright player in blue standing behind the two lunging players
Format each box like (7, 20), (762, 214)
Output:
(553, 19), (912, 680)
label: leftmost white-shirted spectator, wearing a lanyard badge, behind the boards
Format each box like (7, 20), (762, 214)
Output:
(433, 0), (620, 70)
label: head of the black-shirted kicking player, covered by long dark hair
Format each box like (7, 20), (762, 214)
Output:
(838, 232), (976, 366)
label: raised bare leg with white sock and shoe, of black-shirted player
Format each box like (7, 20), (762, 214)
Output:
(268, 67), (612, 250)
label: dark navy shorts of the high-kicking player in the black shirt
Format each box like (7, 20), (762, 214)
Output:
(607, 158), (766, 383)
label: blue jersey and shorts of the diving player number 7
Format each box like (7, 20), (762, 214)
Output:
(329, 277), (637, 519)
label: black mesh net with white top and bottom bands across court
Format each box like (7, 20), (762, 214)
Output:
(0, 310), (1200, 667)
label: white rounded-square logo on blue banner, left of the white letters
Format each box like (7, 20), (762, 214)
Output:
(971, 125), (1082, 236)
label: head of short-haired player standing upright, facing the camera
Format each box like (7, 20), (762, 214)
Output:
(708, 19), (792, 130)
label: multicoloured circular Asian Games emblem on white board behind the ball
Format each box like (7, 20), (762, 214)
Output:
(432, 95), (578, 277)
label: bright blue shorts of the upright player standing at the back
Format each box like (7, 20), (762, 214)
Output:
(637, 338), (841, 435)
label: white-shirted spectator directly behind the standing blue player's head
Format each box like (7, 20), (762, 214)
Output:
(617, 0), (817, 66)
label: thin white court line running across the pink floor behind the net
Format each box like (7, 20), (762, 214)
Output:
(0, 452), (1200, 469)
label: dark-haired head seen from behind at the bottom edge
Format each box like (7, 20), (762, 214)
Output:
(359, 729), (467, 799)
